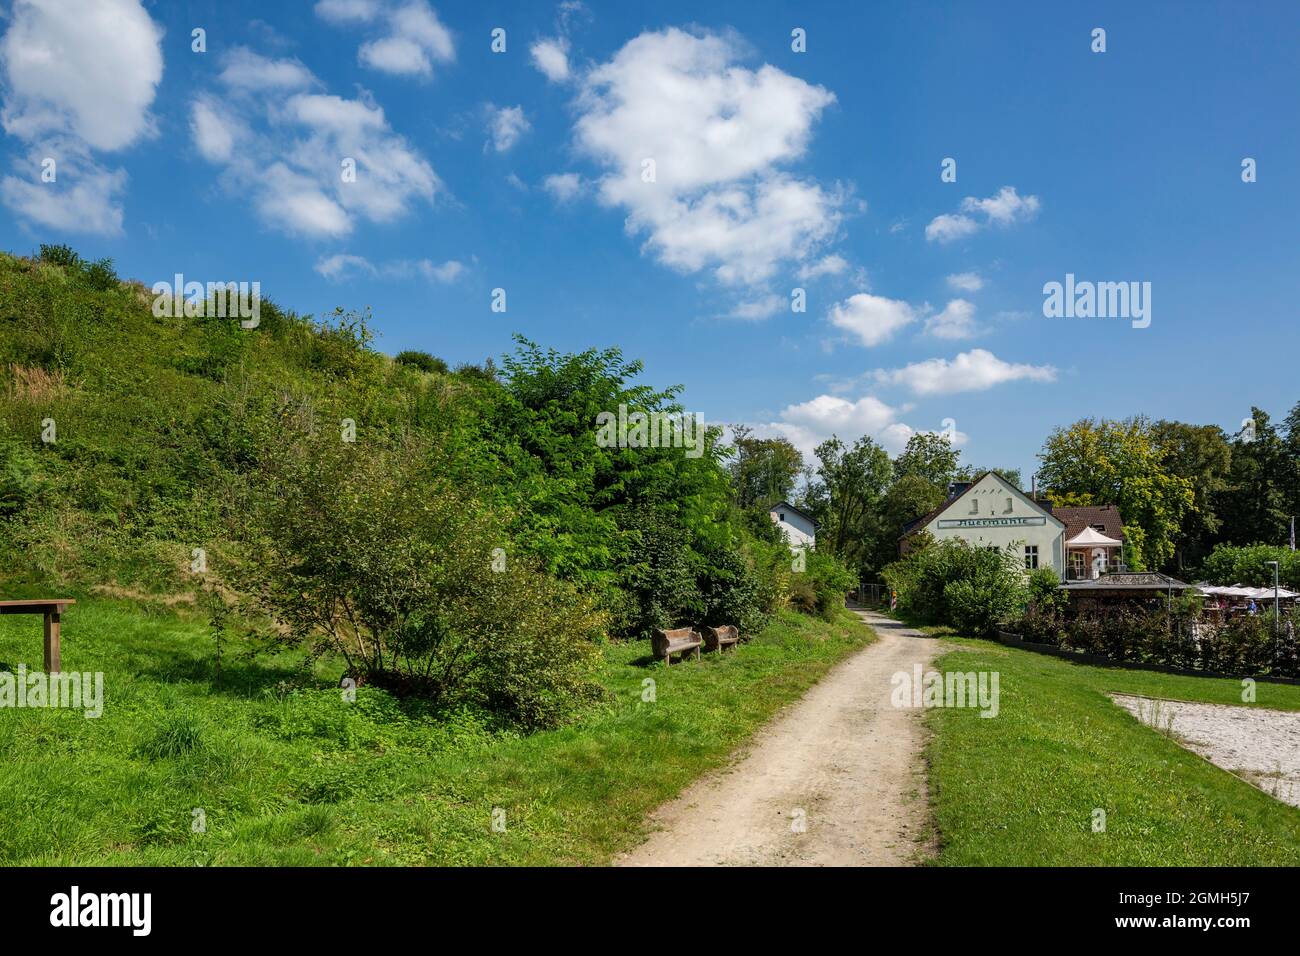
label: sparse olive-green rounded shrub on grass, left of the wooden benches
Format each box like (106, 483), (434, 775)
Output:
(238, 433), (603, 727)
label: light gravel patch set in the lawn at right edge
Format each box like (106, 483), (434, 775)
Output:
(1110, 693), (1300, 806)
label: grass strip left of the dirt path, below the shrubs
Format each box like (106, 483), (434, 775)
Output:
(0, 598), (871, 865)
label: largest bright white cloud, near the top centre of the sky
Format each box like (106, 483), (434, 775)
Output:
(575, 29), (844, 291)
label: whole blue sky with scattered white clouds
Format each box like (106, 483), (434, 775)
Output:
(0, 0), (1300, 476)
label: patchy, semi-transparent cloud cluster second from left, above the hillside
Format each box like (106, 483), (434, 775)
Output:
(190, 51), (442, 238)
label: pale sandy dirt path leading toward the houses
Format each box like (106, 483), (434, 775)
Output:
(616, 611), (937, 866)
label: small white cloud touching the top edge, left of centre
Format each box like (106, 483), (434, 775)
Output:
(316, 0), (456, 78)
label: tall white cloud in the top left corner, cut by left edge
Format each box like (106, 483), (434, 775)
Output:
(0, 0), (163, 235)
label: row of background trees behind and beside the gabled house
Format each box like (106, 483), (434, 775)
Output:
(731, 402), (1300, 581)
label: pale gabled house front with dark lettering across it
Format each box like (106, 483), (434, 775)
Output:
(900, 471), (1066, 578)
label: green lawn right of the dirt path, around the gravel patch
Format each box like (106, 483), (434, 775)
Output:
(927, 640), (1300, 866)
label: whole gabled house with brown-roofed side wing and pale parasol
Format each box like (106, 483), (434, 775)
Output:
(898, 471), (1123, 580)
